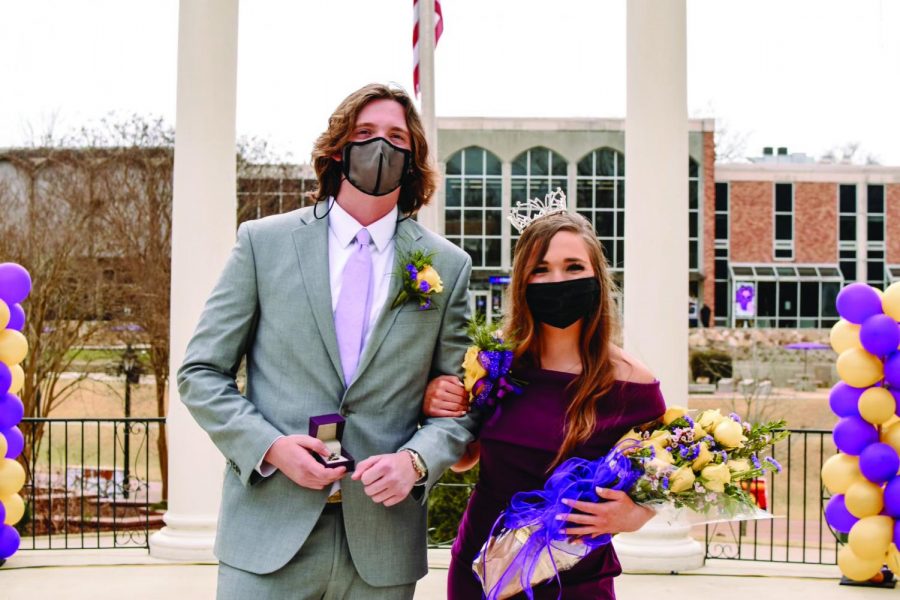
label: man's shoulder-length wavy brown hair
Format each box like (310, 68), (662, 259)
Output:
(312, 83), (438, 214)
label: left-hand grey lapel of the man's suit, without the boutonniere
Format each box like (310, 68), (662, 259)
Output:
(292, 213), (344, 381)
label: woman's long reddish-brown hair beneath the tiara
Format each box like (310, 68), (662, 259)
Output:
(504, 213), (618, 469)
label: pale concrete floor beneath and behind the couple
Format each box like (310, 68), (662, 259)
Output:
(0, 550), (892, 600)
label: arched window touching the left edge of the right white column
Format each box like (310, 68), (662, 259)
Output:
(575, 148), (625, 271)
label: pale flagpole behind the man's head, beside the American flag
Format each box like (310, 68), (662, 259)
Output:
(418, 0), (443, 233)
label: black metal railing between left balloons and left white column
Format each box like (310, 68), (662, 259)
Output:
(16, 418), (165, 550)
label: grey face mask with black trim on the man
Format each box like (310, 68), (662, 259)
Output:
(341, 138), (412, 196)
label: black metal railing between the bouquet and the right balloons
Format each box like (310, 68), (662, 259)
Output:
(703, 429), (838, 565)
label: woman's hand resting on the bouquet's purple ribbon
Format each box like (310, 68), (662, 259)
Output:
(556, 487), (656, 537)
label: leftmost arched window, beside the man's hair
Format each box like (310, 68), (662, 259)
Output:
(444, 146), (503, 269)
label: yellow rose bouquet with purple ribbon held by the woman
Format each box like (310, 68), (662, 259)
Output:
(472, 407), (788, 600)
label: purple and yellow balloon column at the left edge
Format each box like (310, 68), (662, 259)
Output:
(0, 263), (31, 562)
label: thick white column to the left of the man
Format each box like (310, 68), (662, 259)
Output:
(150, 0), (238, 561)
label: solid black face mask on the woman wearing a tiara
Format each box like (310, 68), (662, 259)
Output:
(525, 277), (600, 329)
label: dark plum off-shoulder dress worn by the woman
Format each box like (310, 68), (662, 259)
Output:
(447, 369), (665, 600)
